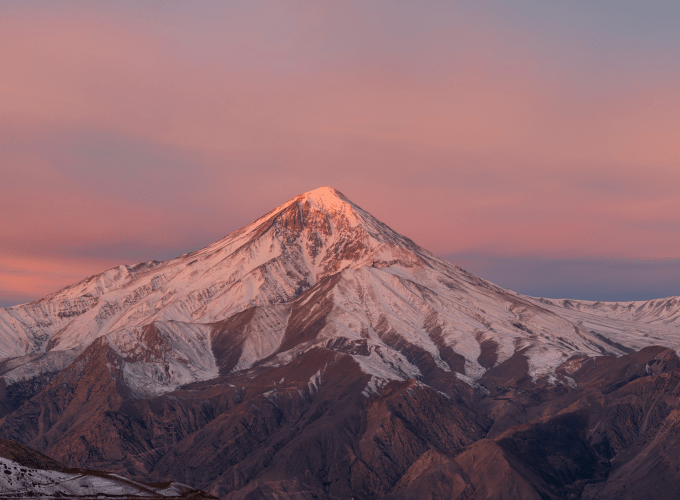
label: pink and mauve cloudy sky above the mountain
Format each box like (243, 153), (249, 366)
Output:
(0, 0), (680, 307)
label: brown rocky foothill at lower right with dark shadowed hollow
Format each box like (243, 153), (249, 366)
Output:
(382, 347), (680, 499)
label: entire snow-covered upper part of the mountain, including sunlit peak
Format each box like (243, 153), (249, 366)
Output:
(0, 188), (680, 395)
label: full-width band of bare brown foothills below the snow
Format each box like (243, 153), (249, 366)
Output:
(0, 342), (680, 499)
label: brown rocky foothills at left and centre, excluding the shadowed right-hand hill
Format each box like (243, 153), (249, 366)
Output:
(0, 345), (489, 498)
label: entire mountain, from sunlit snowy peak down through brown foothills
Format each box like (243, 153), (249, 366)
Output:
(0, 188), (680, 498)
